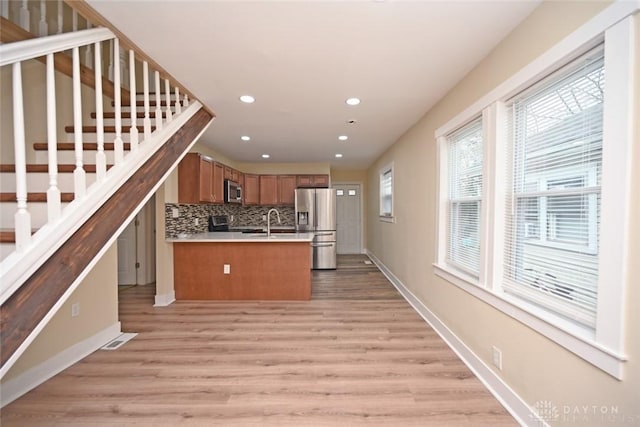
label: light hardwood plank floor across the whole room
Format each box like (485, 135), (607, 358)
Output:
(1, 256), (516, 427)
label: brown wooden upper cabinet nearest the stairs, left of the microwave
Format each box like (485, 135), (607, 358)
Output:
(178, 153), (214, 203)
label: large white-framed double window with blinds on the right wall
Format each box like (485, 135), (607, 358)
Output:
(434, 8), (638, 379)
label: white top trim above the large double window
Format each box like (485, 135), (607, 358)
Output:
(436, 0), (640, 137)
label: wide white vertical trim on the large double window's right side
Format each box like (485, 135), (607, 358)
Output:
(596, 12), (640, 351)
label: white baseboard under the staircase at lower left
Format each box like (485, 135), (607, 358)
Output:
(0, 322), (121, 407)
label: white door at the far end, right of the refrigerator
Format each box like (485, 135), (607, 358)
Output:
(333, 184), (362, 254)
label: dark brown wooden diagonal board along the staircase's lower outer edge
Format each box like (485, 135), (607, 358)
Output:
(0, 108), (213, 372)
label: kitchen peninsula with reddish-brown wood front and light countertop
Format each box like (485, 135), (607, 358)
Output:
(167, 232), (313, 300)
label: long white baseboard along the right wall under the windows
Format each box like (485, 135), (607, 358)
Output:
(367, 251), (544, 426)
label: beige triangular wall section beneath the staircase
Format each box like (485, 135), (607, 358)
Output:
(2, 243), (119, 386)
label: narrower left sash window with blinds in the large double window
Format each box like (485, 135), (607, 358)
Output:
(446, 117), (482, 277)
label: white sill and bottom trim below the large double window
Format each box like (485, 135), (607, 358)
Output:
(433, 264), (627, 379)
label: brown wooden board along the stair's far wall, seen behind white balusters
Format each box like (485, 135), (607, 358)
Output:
(0, 17), (130, 104)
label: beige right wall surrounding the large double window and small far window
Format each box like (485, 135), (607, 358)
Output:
(367, 2), (640, 425)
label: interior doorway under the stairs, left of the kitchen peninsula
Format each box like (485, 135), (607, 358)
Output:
(118, 196), (156, 286)
